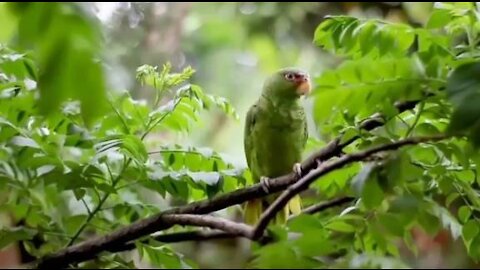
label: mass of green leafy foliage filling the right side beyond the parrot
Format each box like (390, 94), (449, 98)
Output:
(249, 3), (480, 268)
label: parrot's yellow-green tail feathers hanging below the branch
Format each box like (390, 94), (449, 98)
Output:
(244, 195), (302, 226)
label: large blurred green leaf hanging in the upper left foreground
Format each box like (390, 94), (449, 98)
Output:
(15, 3), (106, 124)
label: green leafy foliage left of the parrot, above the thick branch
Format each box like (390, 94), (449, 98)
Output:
(0, 4), (240, 267)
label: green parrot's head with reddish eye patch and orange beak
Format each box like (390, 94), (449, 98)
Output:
(264, 68), (311, 98)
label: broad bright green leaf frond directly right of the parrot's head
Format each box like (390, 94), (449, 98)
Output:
(313, 57), (428, 133)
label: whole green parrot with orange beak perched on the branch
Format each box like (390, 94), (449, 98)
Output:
(244, 68), (311, 225)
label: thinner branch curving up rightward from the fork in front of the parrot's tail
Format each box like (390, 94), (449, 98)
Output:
(253, 134), (449, 240)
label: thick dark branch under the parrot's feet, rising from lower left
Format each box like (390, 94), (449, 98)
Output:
(33, 97), (424, 268)
